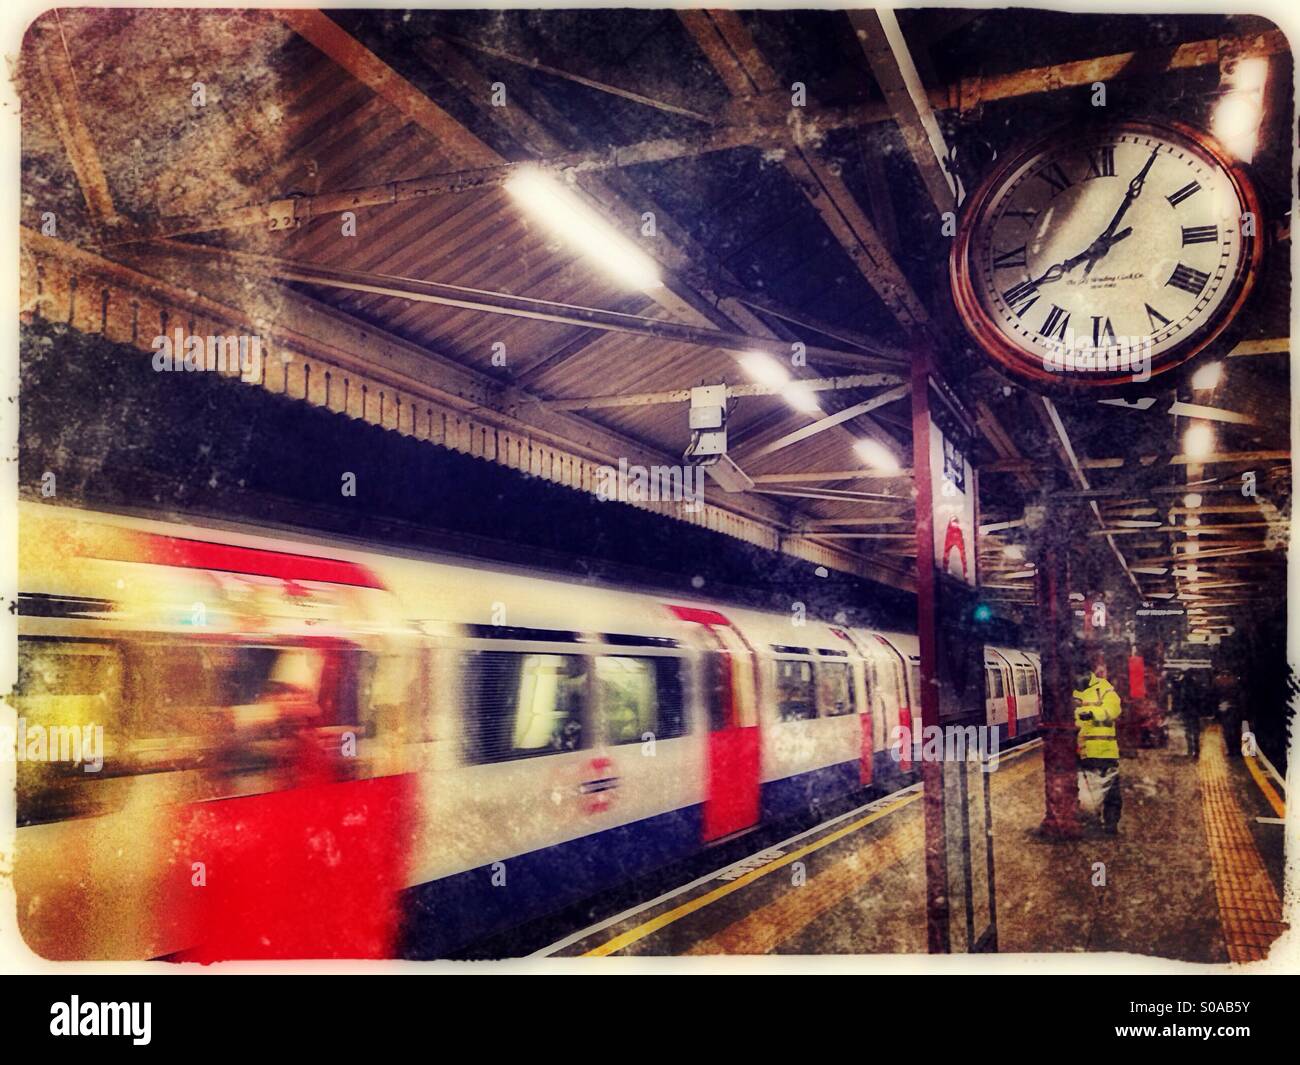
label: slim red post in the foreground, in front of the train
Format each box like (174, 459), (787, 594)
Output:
(911, 347), (950, 954)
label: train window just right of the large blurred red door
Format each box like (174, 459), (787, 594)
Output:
(463, 651), (588, 763)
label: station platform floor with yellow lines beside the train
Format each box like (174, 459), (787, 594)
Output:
(545, 724), (1284, 962)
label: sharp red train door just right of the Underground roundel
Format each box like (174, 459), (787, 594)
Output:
(670, 606), (762, 843)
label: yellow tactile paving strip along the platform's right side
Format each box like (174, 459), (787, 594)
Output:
(1197, 724), (1286, 962)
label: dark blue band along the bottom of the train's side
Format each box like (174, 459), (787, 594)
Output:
(402, 752), (910, 958)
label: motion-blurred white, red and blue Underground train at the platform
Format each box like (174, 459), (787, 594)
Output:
(12, 502), (1041, 961)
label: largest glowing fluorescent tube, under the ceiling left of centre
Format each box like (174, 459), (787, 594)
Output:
(506, 168), (663, 290)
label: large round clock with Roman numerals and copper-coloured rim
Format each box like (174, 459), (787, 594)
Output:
(950, 121), (1264, 388)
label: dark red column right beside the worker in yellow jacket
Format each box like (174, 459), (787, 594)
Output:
(1037, 520), (1082, 839)
